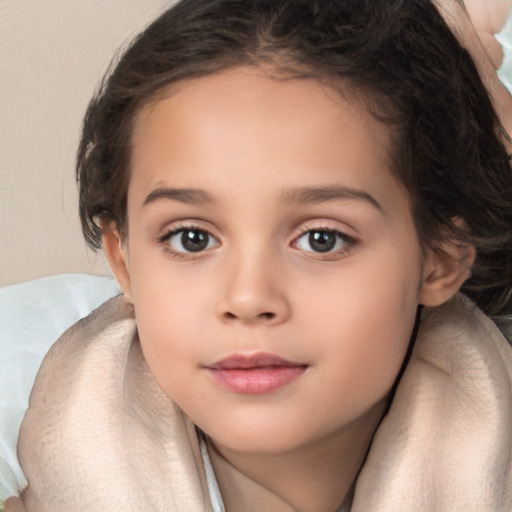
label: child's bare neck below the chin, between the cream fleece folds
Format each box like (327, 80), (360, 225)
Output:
(208, 401), (385, 512)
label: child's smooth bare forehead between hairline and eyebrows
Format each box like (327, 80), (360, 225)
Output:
(129, 68), (402, 208)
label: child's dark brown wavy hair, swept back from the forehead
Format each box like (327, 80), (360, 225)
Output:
(77, 0), (512, 314)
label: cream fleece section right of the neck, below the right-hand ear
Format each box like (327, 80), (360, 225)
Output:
(355, 295), (512, 512)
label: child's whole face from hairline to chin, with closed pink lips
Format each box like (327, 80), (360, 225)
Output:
(113, 68), (444, 453)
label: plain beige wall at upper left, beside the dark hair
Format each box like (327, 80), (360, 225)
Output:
(0, 0), (167, 286)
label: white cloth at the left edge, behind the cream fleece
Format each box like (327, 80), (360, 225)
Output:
(0, 274), (120, 500)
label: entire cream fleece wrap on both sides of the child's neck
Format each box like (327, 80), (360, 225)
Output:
(19, 296), (512, 512)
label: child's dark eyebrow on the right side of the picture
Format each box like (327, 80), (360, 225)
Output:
(281, 185), (384, 213)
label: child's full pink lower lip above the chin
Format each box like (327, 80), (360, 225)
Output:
(209, 366), (307, 395)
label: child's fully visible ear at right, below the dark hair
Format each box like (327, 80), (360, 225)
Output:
(418, 240), (476, 306)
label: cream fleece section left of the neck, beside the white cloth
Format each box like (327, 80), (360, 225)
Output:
(18, 296), (207, 512)
